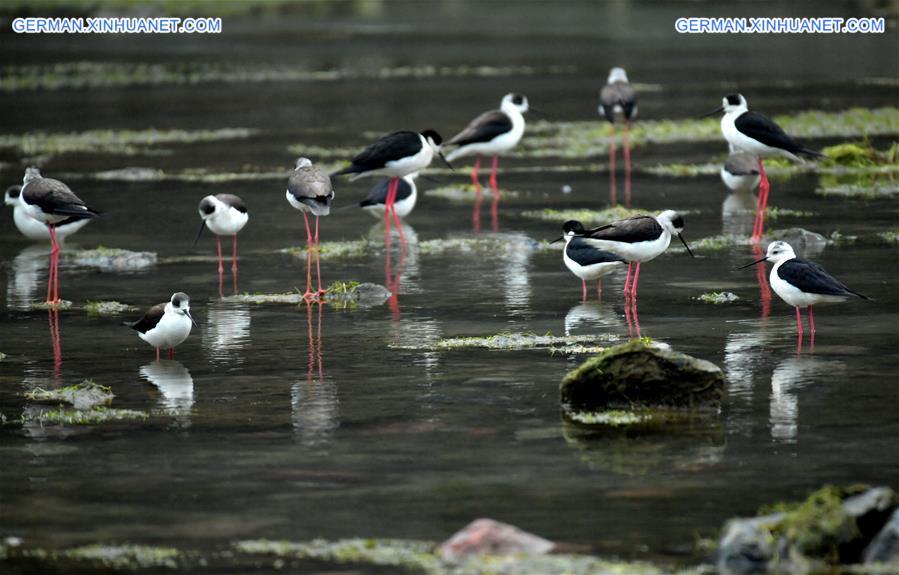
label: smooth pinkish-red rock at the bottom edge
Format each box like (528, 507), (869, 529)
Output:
(437, 519), (555, 560)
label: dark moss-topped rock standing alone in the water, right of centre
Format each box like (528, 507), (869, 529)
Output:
(559, 340), (724, 412)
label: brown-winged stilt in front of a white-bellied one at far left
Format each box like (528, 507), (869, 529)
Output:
(20, 166), (99, 304)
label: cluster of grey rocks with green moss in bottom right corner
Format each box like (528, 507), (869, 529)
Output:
(715, 486), (899, 573)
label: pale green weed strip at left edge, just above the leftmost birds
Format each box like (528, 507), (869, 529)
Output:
(0, 128), (257, 156)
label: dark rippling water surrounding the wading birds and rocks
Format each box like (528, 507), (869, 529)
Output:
(0, 2), (899, 568)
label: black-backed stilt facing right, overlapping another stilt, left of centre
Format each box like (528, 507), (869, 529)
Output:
(331, 130), (452, 246)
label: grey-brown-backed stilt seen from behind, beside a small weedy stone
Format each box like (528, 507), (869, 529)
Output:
(286, 158), (334, 301)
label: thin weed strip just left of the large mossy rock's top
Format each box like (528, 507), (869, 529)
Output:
(391, 332), (616, 352)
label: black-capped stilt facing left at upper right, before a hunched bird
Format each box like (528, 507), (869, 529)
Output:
(706, 94), (824, 243)
